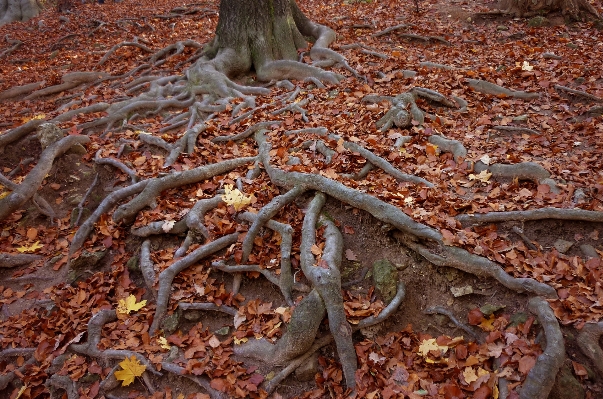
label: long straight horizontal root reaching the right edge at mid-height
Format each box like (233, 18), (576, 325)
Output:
(455, 208), (603, 226)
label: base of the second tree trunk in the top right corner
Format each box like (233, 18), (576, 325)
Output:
(498, 0), (600, 21)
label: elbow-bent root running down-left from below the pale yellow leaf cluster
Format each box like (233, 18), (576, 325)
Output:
(149, 233), (239, 334)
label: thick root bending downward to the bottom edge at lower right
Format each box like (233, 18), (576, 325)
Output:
(519, 297), (565, 399)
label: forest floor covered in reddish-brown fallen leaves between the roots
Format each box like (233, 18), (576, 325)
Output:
(0, 0), (603, 399)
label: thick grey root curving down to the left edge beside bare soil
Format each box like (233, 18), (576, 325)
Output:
(0, 136), (90, 220)
